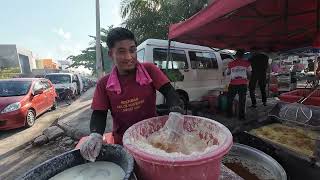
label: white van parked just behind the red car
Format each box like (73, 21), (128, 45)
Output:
(45, 73), (83, 95)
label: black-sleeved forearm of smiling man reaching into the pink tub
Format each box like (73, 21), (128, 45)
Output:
(159, 82), (184, 113)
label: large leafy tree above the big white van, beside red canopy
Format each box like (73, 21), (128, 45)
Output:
(121, 0), (208, 43)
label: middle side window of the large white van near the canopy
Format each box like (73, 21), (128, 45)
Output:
(189, 51), (218, 69)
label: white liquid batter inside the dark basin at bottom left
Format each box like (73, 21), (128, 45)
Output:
(50, 161), (125, 180)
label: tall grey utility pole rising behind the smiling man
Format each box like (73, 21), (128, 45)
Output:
(96, 0), (103, 79)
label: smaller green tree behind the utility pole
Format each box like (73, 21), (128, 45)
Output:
(67, 26), (113, 74)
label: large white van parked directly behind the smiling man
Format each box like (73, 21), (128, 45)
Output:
(137, 39), (233, 104)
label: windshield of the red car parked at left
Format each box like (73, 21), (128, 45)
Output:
(0, 81), (31, 97)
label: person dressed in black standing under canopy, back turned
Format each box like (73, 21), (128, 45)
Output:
(249, 49), (269, 108)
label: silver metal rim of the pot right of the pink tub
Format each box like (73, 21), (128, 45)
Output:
(224, 143), (287, 180)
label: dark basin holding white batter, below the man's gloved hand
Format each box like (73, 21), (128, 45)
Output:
(18, 144), (135, 180)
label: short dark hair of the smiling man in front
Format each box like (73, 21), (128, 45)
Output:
(107, 27), (137, 49)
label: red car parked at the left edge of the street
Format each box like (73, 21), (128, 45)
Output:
(0, 78), (57, 130)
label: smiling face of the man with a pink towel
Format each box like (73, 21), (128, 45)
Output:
(109, 40), (137, 73)
